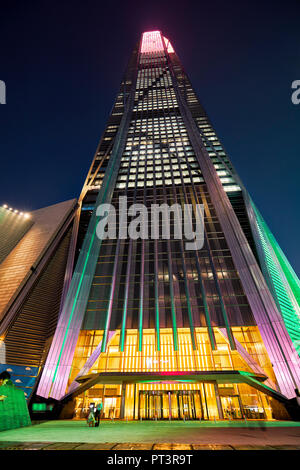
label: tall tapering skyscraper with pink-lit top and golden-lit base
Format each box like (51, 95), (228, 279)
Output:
(36, 31), (300, 419)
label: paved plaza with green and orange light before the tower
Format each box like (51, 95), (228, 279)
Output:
(0, 420), (300, 450)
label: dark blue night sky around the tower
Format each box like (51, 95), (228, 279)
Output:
(0, 0), (300, 274)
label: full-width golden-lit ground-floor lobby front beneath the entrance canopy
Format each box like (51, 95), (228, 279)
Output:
(73, 380), (272, 421)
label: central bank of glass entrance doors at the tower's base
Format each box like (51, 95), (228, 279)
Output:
(138, 390), (204, 420)
